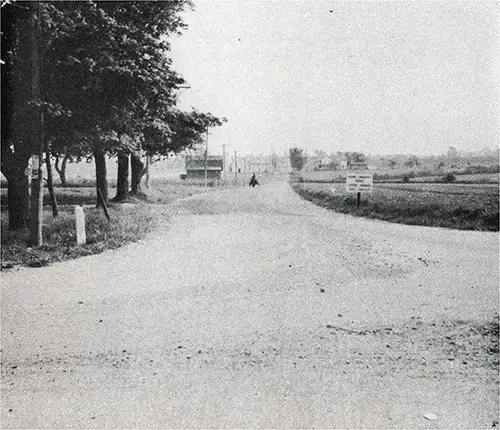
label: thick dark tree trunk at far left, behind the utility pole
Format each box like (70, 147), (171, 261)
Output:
(6, 163), (29, 230)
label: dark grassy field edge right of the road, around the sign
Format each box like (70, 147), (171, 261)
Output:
(292, 183), (499, 231)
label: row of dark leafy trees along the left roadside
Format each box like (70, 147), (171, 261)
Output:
(1, 0), (225, 229)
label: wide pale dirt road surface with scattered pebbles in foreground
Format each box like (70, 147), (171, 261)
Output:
(1, 183), (499, 429)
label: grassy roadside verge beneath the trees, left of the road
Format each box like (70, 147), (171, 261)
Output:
(1, 184), (211, 270)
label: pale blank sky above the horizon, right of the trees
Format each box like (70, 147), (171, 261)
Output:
(169, 0), (500, 155)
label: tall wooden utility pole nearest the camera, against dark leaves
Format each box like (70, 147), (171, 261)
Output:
(29, 0), (44, 247)
